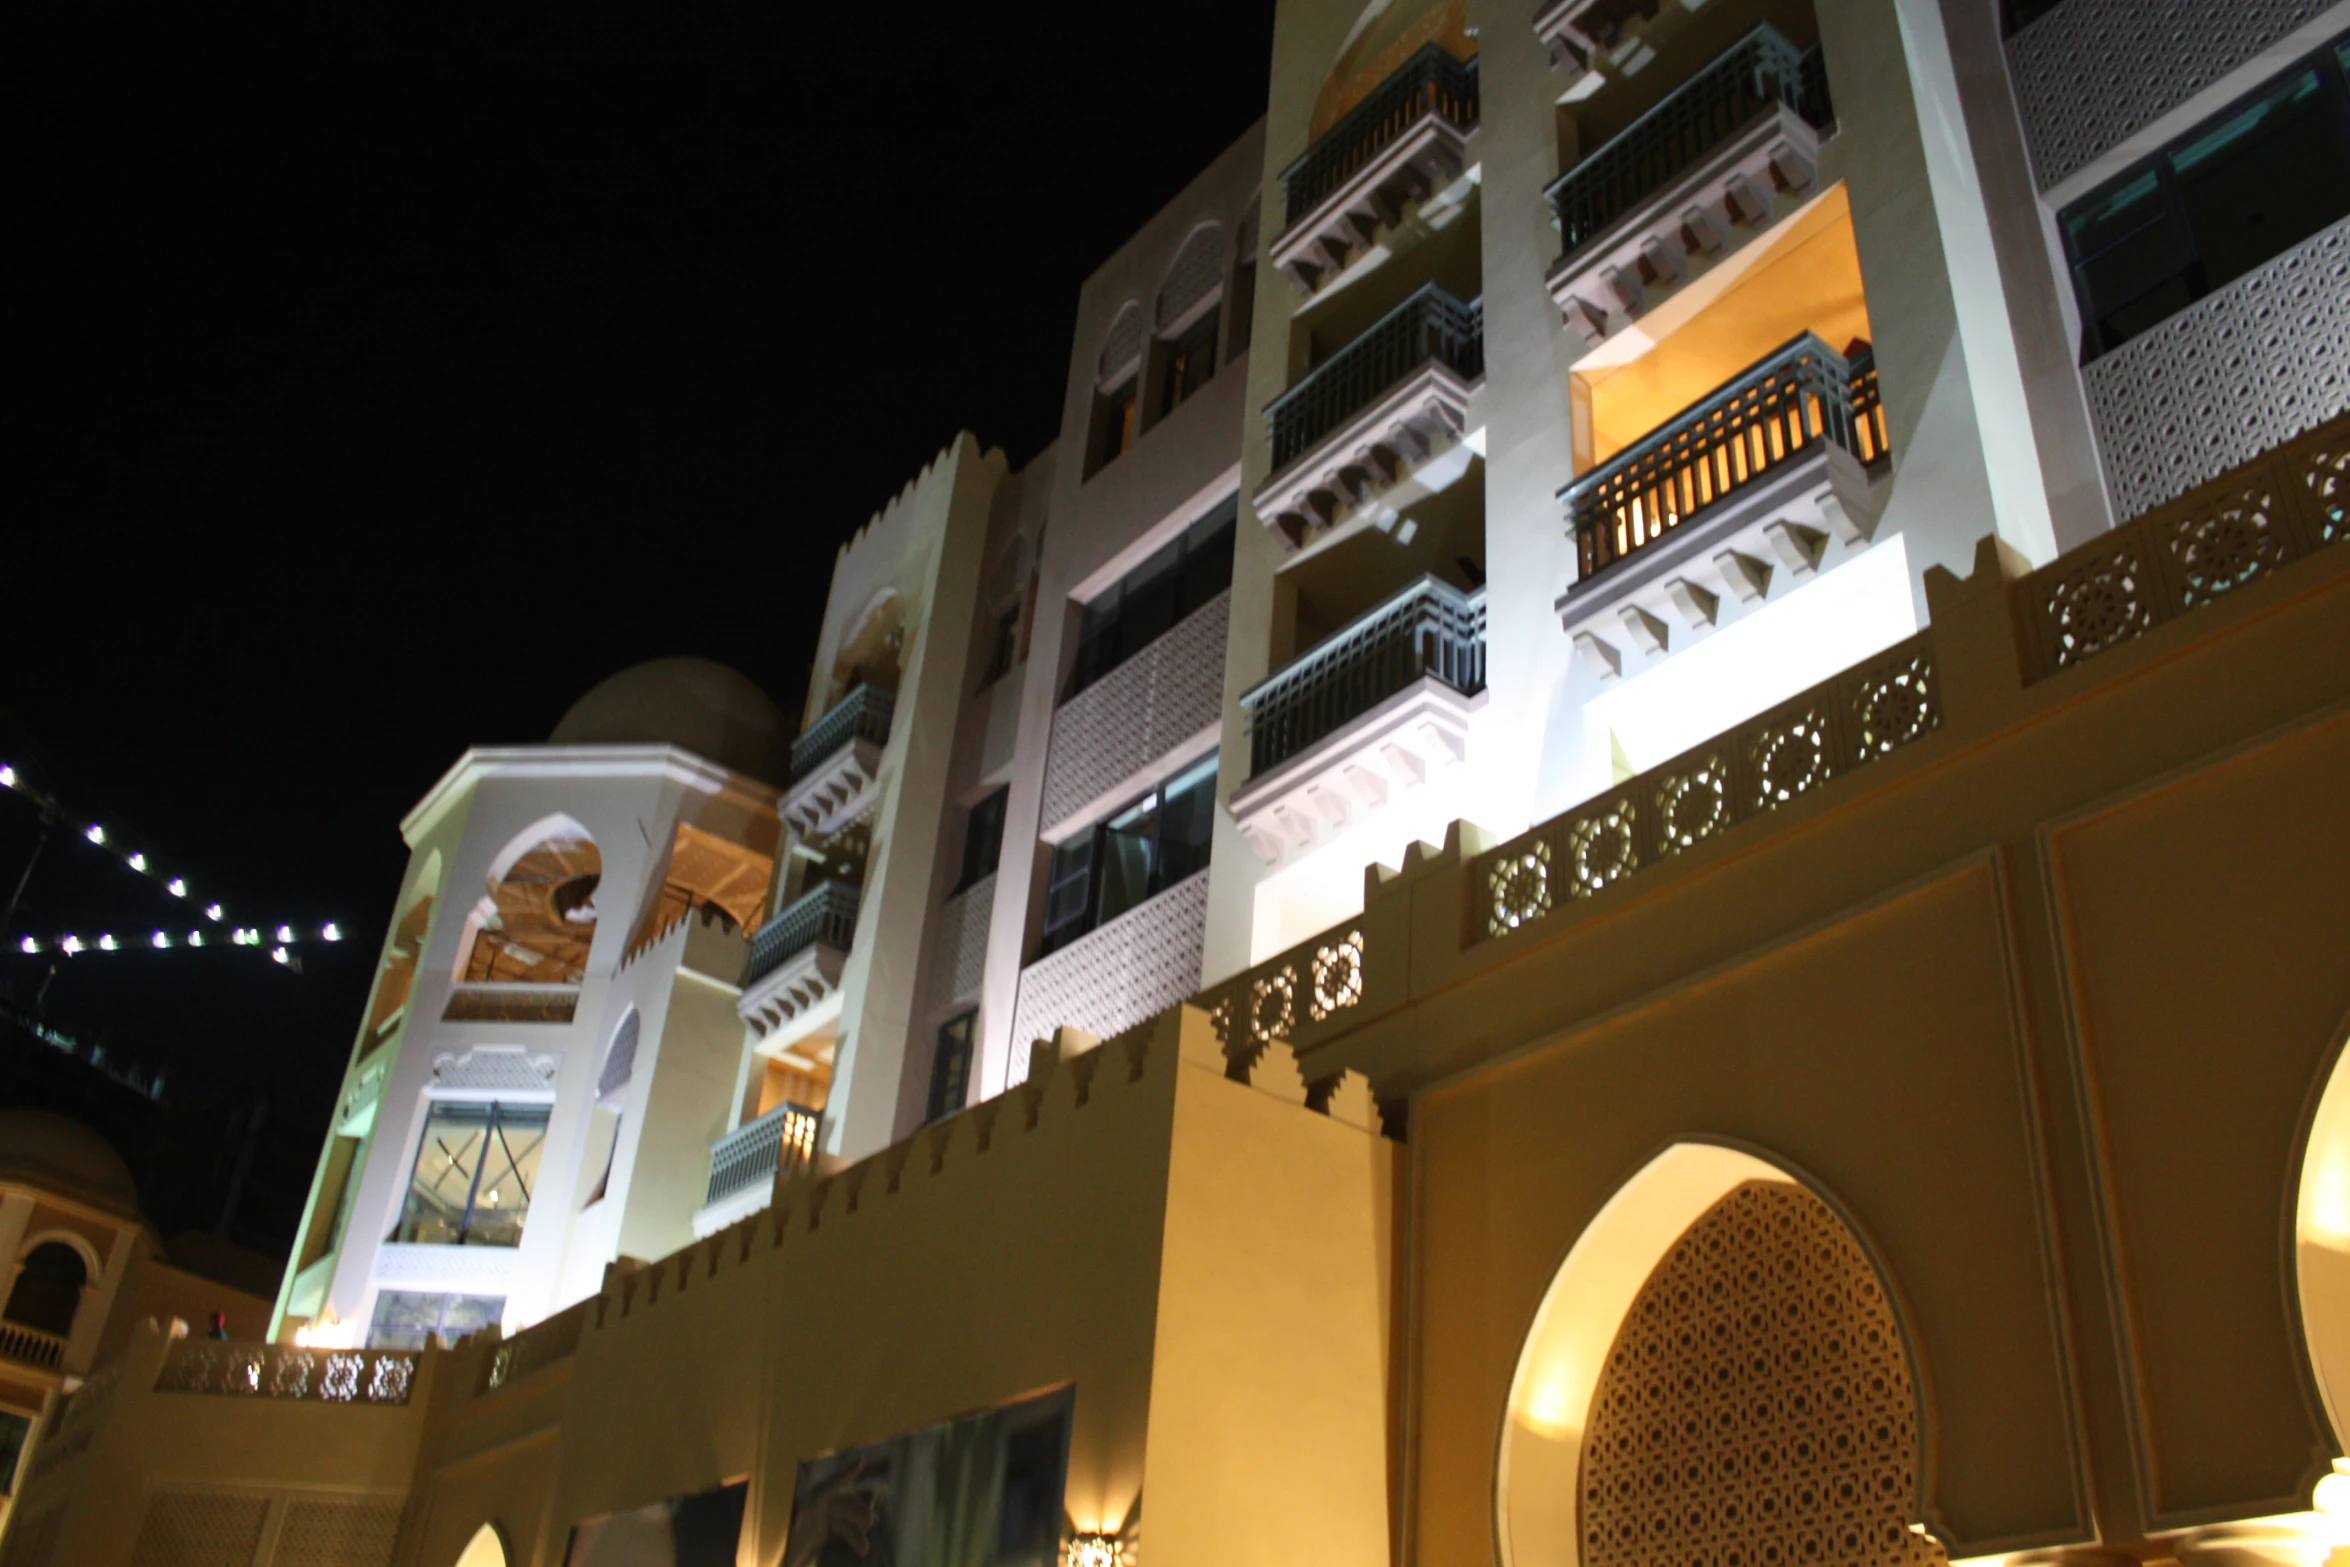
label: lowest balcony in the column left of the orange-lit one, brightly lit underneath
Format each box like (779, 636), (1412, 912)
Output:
(1231, 578), (1485, 865)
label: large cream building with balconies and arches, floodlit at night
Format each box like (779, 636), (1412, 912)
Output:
(0, 0), (2350, 1567)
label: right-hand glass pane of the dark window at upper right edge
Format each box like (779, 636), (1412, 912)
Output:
(2171, 70), (2350, 289)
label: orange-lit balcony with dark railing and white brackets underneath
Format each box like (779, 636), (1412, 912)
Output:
(1556, 334), (1887, 681)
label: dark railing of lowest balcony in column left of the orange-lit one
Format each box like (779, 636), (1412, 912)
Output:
(1241, 576), (1485, 778)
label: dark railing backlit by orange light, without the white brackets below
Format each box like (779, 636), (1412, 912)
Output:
(1558, 331), (1885, 583)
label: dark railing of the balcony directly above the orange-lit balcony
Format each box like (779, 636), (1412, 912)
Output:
(1546, 23), (1835, 256)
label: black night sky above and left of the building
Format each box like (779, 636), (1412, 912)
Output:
(0, 0), (1271, 1123)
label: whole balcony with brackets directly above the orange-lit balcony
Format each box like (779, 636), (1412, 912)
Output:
(1546, 26), (1833, 345)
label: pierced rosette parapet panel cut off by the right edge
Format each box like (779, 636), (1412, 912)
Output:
(2014, 416), (2350, 681)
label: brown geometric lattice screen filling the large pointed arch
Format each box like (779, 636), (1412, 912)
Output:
(1582, 1182), (1946, 1567)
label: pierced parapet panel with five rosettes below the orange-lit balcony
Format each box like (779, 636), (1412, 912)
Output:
(1469, 632), (1941, 940)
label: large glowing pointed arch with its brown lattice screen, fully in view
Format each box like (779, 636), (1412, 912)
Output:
(1495, 1144), (1948, 1567)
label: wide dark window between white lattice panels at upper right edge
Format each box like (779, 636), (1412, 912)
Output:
(2056, 45), (2350, 359)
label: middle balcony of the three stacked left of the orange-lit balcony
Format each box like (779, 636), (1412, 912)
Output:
(1255, 284), (1485, 550)
